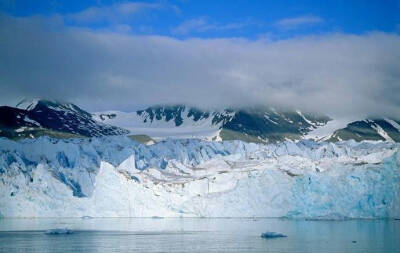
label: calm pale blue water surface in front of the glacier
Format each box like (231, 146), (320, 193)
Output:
(0, 218), (400, 253)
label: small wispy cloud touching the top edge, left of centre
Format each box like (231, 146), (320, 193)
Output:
(66, 2), (162, 24)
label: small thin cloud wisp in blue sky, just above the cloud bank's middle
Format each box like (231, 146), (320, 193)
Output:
(172, 17), (254, 35)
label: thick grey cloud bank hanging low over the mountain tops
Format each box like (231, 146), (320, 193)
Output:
(0, 16), (400, 118)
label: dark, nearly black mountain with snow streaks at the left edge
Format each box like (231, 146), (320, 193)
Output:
(0, 100), (128, 138)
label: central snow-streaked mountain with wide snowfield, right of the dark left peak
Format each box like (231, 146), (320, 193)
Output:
(94, 105), (330, 143)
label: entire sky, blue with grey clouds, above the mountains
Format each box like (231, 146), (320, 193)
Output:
(0, 0), (400, 118)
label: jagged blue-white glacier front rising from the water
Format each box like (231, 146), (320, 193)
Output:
(0, 136), (400, 219)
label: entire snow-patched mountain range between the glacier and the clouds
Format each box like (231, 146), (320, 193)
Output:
(0, 100), (400, 143)
